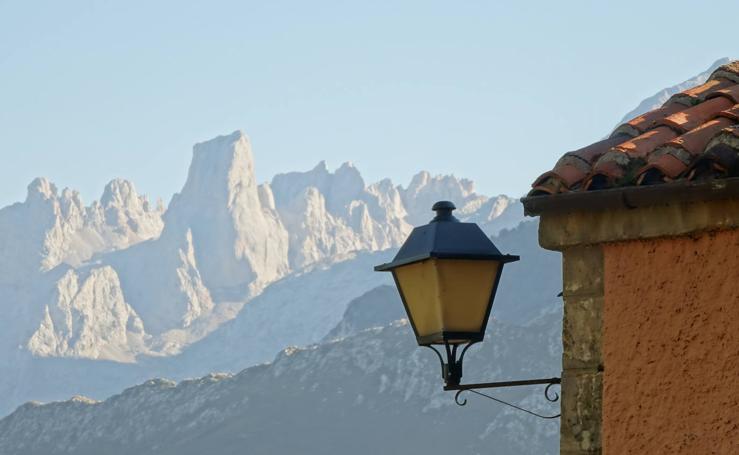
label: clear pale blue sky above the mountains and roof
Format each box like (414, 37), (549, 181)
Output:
(0, 0), (739, 206)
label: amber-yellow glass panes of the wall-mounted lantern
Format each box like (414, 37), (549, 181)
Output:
(394, 258), (500, 343)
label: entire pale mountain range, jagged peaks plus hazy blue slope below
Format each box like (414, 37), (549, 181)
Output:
(0, 131), (523, 413)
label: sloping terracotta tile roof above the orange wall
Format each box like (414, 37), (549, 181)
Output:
(529, 61), (739, 196)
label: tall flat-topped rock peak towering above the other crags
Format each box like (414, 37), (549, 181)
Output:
(162, 131), (288, 298)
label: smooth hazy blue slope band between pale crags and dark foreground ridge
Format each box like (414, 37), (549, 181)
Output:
(0, 252), (392, 420)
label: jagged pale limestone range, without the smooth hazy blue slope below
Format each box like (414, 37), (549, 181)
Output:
(0, 131), (521, 362)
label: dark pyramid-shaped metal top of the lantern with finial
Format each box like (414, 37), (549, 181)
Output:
(375, 201), (519, 272)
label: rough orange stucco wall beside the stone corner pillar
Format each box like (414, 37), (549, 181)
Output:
(602, 230), (739, 455)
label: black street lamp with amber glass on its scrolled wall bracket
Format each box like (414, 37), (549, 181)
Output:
(375, 201), (560, 412)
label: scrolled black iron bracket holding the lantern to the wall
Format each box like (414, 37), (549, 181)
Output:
(426, 342), (562, 419)
